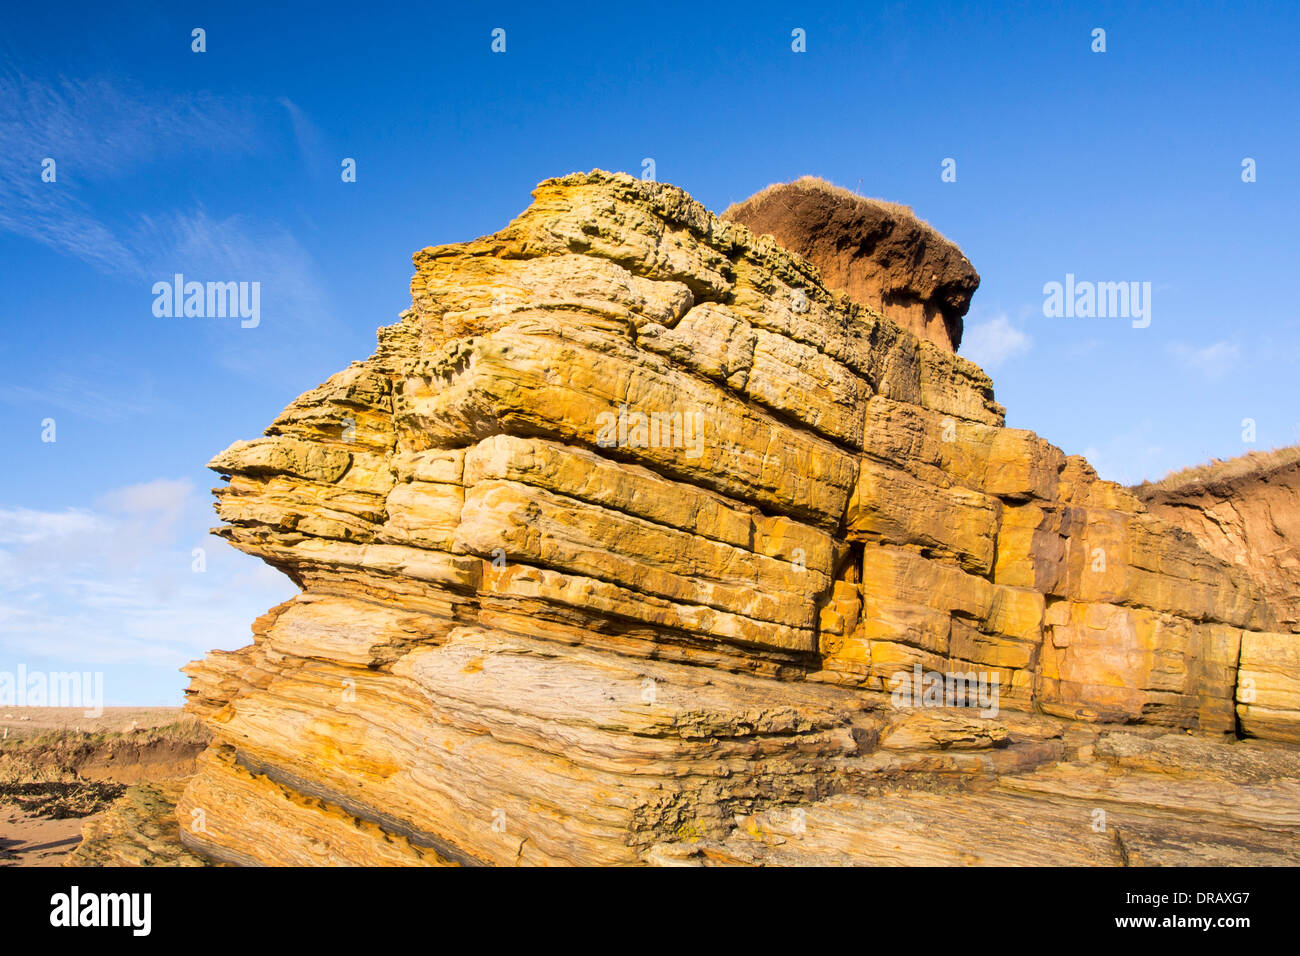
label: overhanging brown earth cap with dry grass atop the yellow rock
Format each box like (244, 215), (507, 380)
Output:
(722, 177), (979, 351)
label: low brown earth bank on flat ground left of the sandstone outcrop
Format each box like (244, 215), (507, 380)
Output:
(0, 708), (209, 866)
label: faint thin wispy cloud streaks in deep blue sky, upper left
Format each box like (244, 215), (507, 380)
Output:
(0, 72), (333, 377)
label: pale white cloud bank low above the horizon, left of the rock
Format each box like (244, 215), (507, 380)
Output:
(0, 479), (296, 671)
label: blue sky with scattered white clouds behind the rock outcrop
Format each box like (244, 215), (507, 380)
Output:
(0, 3), (1300, 704)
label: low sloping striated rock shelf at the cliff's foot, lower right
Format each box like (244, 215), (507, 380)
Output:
(660, 732), (1300, 866)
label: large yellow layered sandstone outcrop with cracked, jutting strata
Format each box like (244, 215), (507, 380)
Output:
(177, 172), (1300, 865)
